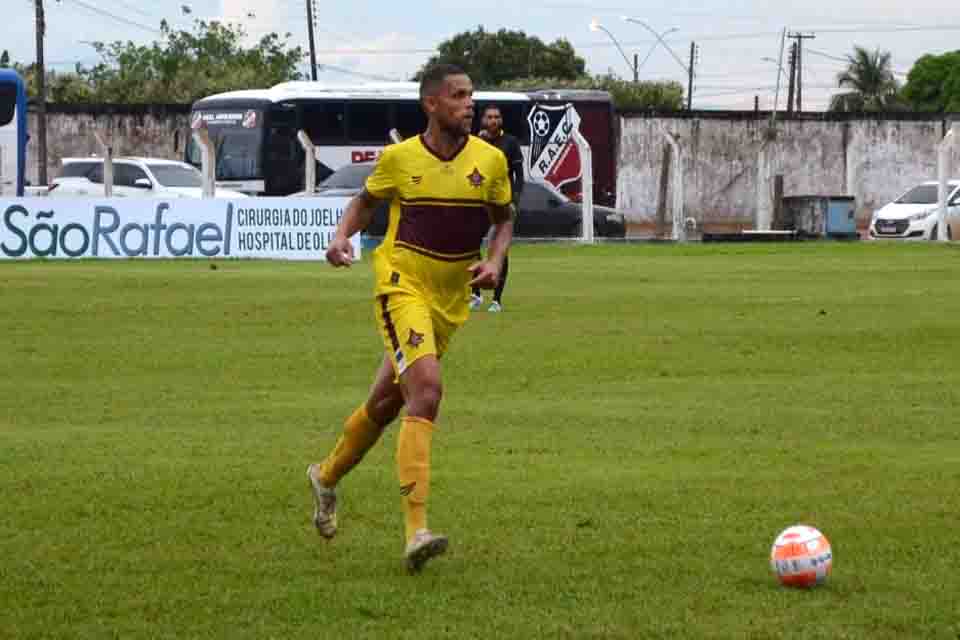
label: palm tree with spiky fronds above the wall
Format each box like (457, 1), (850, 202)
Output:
(830, 46), (900, 111)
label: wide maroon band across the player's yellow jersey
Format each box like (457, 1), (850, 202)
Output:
(396, 203), (490, 256)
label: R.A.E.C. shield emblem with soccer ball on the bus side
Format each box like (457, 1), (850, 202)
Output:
(527, 104), (583, 187)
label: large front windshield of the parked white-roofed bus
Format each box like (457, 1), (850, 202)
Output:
(187, 110), (263, 180)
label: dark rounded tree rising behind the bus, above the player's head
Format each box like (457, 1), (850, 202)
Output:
(415, 27), (586, 87)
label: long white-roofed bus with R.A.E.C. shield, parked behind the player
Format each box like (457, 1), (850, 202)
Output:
(185, 82), (616, 204)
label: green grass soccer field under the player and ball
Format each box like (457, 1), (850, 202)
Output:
(0, 243), (960, 640)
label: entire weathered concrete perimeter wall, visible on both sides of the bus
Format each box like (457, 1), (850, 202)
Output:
(27, 104), (960, 231)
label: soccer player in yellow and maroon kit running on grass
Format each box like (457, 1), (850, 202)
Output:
(307, 65), (513, 573)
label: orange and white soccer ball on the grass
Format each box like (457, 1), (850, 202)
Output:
(770, 524), (833, 588)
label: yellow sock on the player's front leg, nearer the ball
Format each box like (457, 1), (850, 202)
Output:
(397, 416), (433, 542)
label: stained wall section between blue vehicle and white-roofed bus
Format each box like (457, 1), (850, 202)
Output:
(27, 105), (190, 184)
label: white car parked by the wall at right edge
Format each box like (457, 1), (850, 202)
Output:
(870, 180), (960, 240)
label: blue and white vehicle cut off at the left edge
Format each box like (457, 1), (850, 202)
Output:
(0, 69), (27, 197)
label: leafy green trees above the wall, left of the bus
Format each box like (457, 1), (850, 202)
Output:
(3, 21), (303, 104)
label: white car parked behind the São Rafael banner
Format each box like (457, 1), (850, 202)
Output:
(47, 157), (248, 198)
